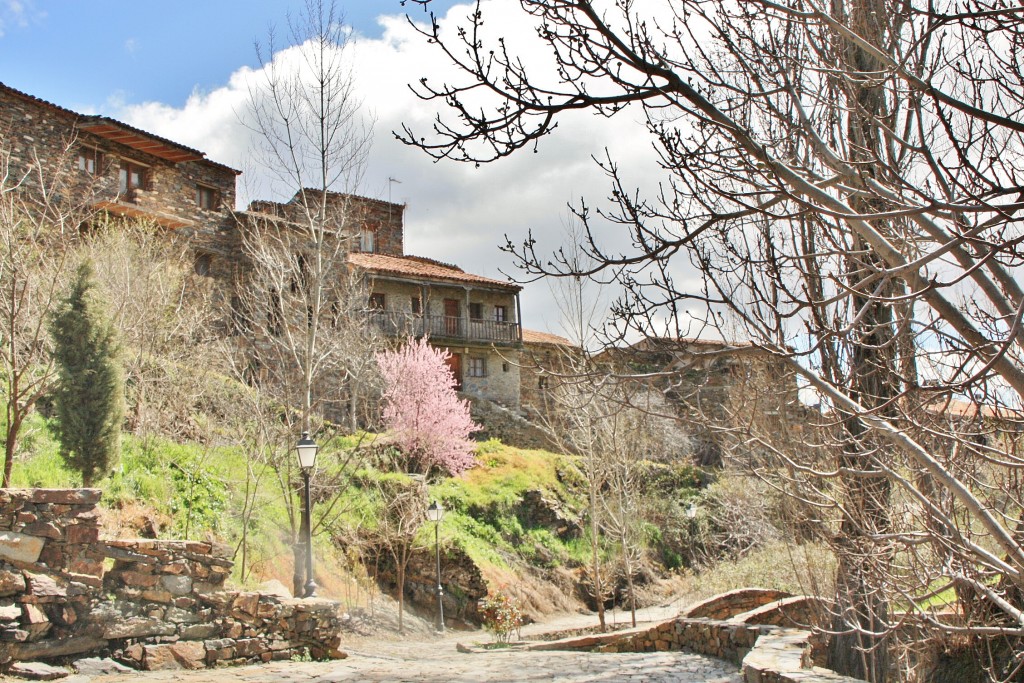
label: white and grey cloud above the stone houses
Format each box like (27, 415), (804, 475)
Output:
(116, 3), (675, 339)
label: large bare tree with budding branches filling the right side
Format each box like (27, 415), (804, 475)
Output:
(404, 0), (1024, 681)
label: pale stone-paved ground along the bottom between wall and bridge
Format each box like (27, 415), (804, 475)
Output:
(28, 609), (741, 683)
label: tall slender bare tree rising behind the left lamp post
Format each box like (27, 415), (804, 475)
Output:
(241, 0), (373, 590)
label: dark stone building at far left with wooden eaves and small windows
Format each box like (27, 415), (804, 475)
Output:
(0, 83), (240, 255)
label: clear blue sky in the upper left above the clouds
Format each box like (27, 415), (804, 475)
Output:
(0, 0), (455, 111)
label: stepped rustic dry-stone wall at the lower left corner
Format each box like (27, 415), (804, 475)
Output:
(0, 489), (344, 670)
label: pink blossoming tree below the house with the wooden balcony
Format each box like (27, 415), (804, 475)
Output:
(377, 339), (480, 474)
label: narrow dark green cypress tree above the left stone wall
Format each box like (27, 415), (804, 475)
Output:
(50, 260), (124, 486)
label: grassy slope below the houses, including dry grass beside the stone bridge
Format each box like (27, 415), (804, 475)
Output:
(13, 416), (830, 607)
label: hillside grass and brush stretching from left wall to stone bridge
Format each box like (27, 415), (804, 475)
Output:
(6, 415), (828, 617)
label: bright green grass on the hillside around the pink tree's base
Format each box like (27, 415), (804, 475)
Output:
(4, 416), (700, 602)
